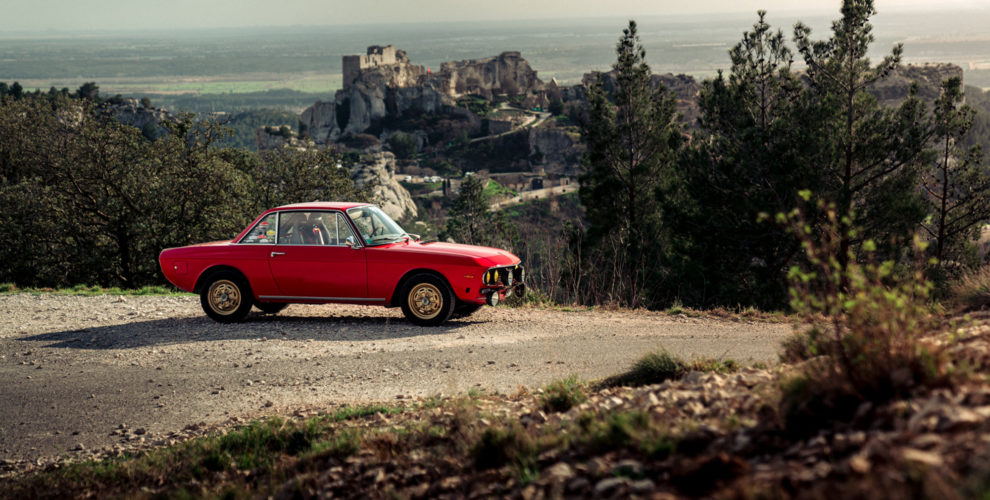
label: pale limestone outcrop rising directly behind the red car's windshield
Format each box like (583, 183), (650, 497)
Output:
(351, 152), (417, 221)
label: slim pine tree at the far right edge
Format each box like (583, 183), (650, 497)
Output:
(921, 77), (990, 266)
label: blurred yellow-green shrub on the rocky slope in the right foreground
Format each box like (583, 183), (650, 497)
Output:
(777, 197), (950, 433)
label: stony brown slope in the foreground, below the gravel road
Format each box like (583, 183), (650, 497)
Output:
(244, 326), (990, 500)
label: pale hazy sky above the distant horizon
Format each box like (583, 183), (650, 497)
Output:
(0, 0), (990, 32)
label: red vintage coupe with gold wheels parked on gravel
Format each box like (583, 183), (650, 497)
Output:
(158, 202), (525, 326)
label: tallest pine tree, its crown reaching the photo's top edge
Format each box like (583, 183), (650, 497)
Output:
(794, 0), (930, 268)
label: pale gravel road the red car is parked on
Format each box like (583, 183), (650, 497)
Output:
(0, 294), (791, 461)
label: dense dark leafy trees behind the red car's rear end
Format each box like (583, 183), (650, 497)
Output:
(0, 92), (362, 288)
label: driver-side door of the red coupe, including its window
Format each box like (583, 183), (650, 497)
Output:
(269, 211), (368, 302)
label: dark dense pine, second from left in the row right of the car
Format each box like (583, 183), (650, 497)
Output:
(664, 11), (822, 308)
